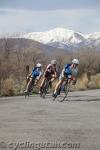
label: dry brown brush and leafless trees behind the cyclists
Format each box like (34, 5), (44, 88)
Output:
(0, 39), (100, 96)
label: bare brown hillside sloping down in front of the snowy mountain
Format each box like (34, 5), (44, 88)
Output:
(0, 38), (66, 53)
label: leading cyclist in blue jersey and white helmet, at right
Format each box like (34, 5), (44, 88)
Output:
(52, 59), (79, 98)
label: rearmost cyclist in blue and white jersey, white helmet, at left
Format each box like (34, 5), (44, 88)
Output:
(24, 63), (42, 93)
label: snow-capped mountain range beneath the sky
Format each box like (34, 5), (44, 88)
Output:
(22, 28), (100, 49)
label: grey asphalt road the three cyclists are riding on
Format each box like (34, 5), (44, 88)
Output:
(0, 90), (100, 150)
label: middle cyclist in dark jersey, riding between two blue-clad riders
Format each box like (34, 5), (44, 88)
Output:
(40, 60), (57, 92)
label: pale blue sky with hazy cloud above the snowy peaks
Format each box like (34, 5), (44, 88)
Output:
(0, 0), (100, 34)
